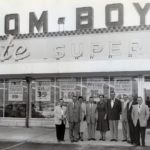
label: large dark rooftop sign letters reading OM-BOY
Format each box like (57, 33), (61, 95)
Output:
(4, 3), (150, 34)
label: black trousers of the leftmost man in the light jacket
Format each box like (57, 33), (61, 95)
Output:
(56, 121), (66, 141)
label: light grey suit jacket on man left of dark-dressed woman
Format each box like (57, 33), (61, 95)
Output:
(86, 103), (98, 123)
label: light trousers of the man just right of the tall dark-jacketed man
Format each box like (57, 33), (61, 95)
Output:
(122, 121), (130, 140)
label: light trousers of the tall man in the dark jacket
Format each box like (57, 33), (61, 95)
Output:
(109, 120), (118, 139)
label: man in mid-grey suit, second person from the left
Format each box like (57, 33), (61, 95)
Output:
(67, 96), (82, 142)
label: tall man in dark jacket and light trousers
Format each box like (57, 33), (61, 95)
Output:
(107, 91), (121, 142)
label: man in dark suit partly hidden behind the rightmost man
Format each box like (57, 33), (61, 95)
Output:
(127, 95), (137, 145)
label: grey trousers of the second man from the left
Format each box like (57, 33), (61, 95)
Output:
(69, 122), (79, 140)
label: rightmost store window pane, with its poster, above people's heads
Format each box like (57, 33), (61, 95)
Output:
(110, 76), (138, 100)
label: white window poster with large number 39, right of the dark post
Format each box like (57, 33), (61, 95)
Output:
(35, 79), (51, 101)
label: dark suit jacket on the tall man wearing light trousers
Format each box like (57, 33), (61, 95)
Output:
(107, 99), (121, 120)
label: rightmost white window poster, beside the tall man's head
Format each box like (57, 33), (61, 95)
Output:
(114, 77), (132, 99)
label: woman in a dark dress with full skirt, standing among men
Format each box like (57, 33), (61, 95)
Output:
(96, 94), (109, 141)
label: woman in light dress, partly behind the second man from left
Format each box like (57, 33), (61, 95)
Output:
(78, 96), (86, 141)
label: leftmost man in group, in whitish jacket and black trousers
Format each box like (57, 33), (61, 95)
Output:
(54, 99), (66, 142)
